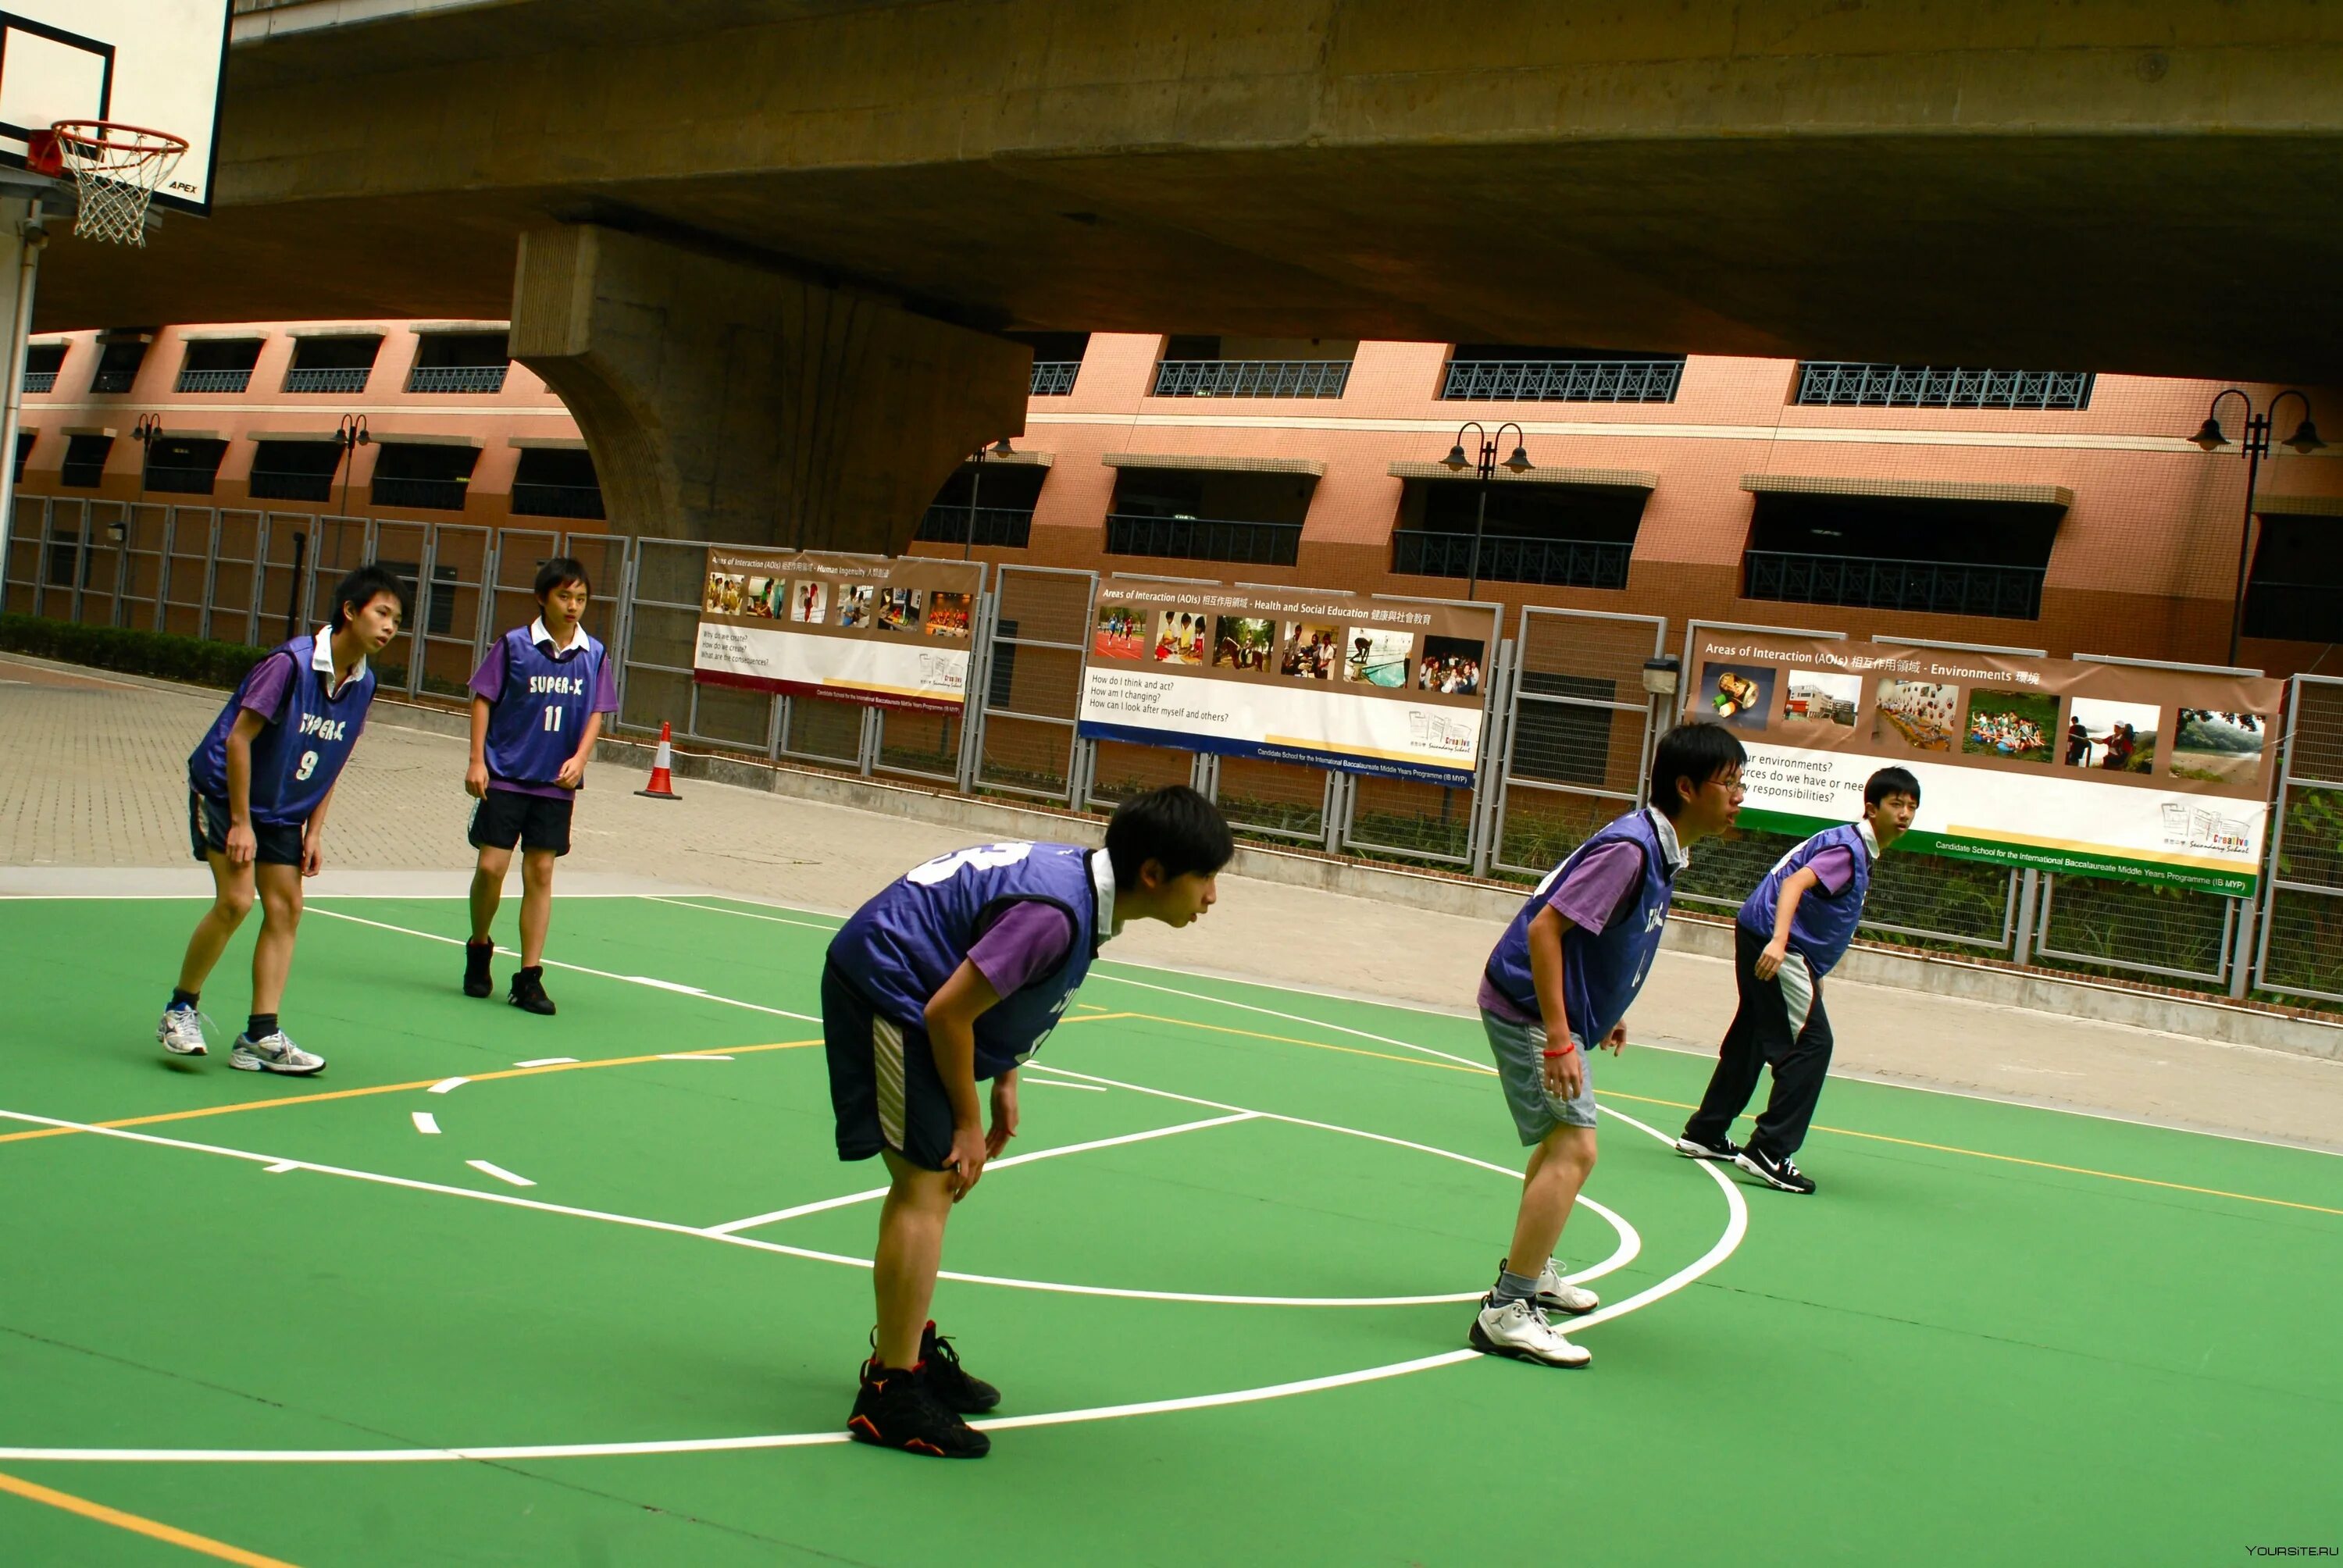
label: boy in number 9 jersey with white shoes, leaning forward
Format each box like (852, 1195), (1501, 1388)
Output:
(155, 565), (408, 1078)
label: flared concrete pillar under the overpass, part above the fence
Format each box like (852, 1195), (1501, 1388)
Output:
(513, 225), (1033, 553)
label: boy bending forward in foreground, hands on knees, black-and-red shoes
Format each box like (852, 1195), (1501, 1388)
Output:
(822, 786), (1235, 1458)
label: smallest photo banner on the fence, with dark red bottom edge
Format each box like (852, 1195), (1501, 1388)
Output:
(691, 543), (984, 712)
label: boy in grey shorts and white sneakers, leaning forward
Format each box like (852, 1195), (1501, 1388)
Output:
(1467, 724), (1746, 1367)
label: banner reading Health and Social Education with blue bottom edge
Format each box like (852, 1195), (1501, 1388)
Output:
(1080, 581), (1497, 788)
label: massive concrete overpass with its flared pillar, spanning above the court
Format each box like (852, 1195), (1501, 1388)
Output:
(40, 0), (2343, 543)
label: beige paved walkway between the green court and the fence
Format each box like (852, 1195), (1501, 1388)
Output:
(13, 656), (2343, 1153)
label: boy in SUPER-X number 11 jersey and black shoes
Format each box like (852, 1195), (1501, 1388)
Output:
(464, 555), (619, 1015)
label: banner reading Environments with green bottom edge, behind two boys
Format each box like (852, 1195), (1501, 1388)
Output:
(1685, 633), (2284, 898)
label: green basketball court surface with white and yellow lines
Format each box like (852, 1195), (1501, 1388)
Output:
(0, 898), (2343, 1568)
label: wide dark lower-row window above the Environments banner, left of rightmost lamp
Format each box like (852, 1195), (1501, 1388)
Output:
(1741, 494), (2059, 621)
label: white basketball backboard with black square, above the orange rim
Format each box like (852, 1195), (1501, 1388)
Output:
(0, 0), (230, 216)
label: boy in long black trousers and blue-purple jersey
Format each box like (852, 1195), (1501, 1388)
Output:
(1675, 768), (1919, 1193)
